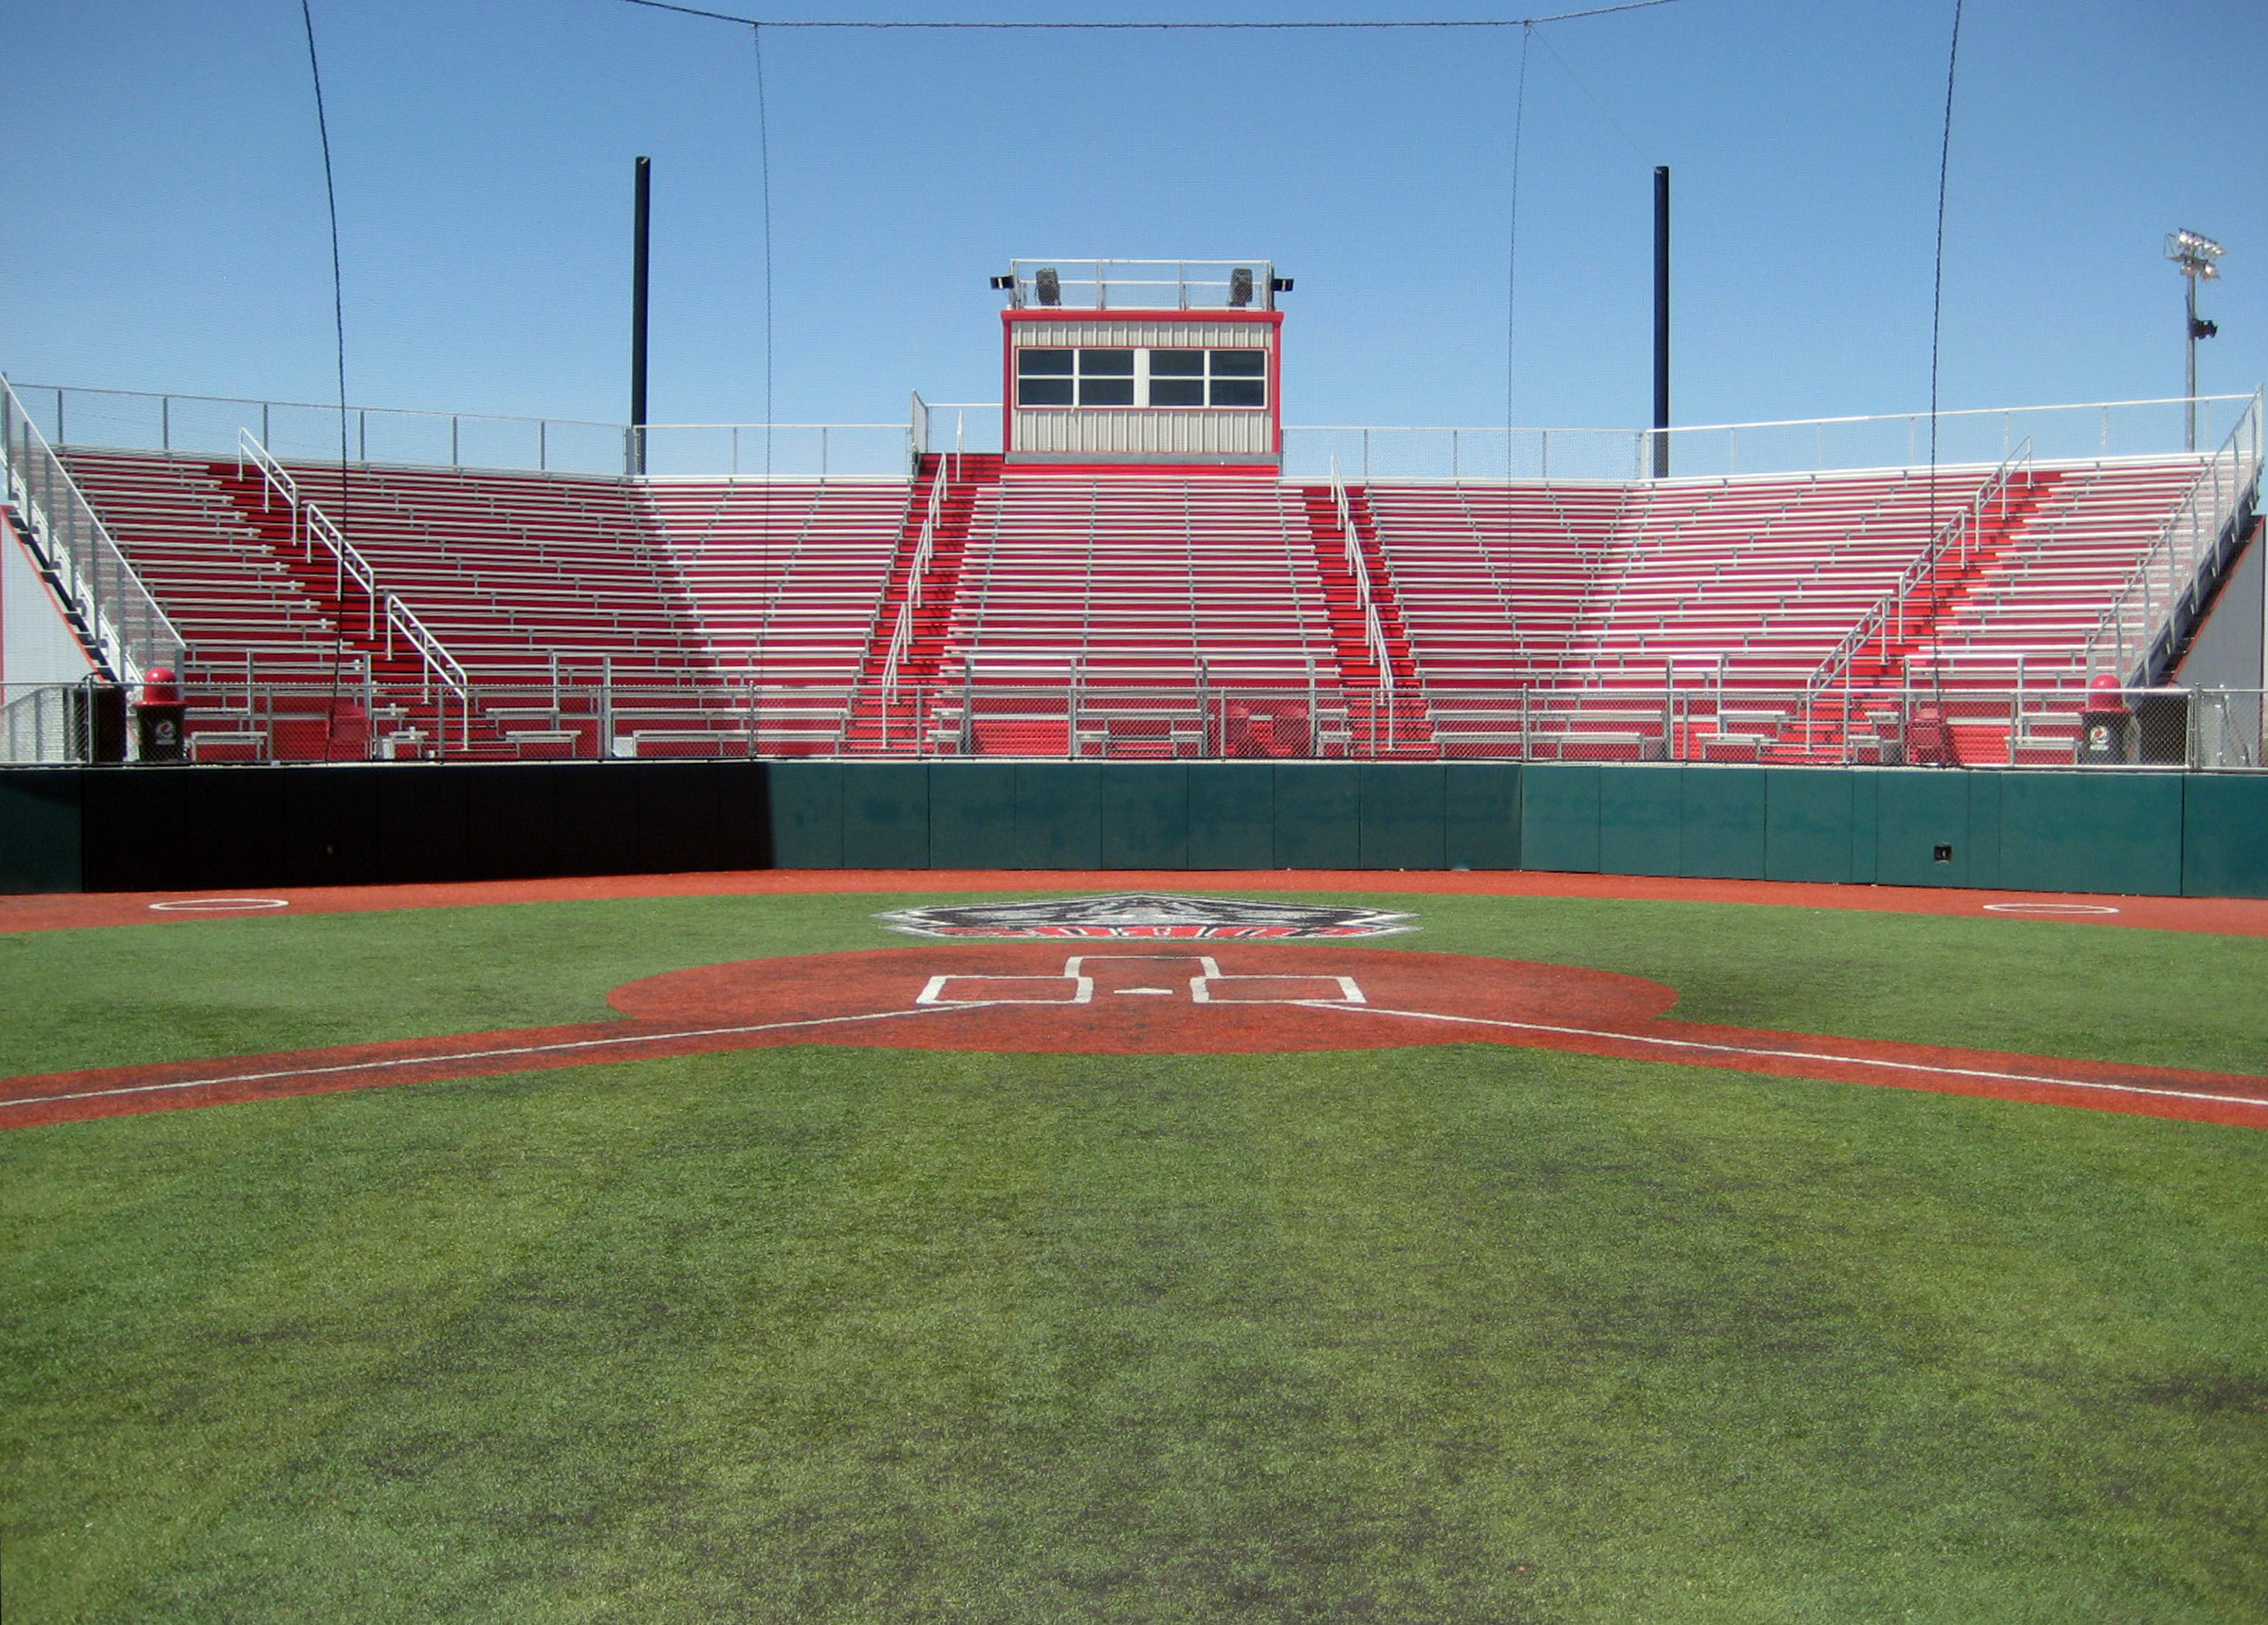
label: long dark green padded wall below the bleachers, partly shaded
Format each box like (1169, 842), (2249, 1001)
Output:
(0, 762), (2268, 896)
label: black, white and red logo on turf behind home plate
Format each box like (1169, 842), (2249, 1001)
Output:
(875, 892), (1418, 942)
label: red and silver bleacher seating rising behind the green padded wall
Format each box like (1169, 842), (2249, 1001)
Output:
(53, 447), (2198, 760)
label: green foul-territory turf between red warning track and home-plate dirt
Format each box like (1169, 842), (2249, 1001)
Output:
(0, 895), (2268, 1076)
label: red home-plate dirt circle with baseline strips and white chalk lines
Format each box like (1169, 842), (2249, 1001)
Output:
(0, 942), (2268, 1128)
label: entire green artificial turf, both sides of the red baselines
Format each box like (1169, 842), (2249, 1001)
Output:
(0, 896), (2268, 1625)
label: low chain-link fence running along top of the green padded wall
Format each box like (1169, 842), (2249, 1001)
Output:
(0, 670), (2268, 771)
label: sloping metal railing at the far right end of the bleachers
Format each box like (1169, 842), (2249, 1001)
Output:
(2080, 393), (2262, 683)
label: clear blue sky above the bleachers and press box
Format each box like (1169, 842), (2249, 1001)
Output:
(0, 0), (2268, 426)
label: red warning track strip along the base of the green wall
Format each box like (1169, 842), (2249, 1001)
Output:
(0, 869), (2268, 937)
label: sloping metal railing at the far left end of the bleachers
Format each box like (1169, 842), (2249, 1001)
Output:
(0, 379), (184, 680)
